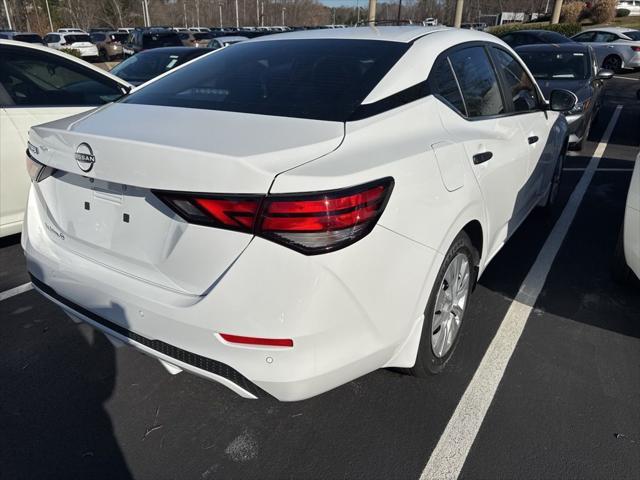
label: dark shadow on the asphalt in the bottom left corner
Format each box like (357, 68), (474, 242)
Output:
(0, 291), (132, 480)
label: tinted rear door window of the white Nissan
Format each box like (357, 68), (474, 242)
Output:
(449, 47), (504, 117)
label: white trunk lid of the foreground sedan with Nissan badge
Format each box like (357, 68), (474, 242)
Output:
(30, 104), (344, 295)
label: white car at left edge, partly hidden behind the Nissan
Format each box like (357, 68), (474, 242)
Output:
(0, 40), (131, 237)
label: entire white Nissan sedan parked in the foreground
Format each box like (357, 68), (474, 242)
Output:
(22, 27), (575, 400)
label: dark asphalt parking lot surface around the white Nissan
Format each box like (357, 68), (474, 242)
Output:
(0, 69), (640, 479)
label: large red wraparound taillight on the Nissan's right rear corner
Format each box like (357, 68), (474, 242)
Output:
(155, 178), (393, 255)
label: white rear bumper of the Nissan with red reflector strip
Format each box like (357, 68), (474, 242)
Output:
(22, 185), (441, 401)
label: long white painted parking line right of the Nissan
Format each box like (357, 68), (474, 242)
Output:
(420, 105), (622, 480)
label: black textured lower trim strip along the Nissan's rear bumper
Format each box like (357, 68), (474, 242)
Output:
(29, 272), (273, 398)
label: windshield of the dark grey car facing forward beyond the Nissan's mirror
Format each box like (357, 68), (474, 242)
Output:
(518, 51), (589, 80)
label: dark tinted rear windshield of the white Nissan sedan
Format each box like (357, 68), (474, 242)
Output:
(123, 39), (409, 122)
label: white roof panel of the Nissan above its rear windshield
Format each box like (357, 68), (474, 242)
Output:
(250, 25), (449, 43)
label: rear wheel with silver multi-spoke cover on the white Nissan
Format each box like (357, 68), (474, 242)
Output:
(409, 232), (479, 377)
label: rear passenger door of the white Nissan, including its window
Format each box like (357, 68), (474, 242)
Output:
(440, 44), (528, 257)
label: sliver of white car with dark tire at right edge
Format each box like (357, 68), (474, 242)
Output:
(613, 153), (640, 282)
